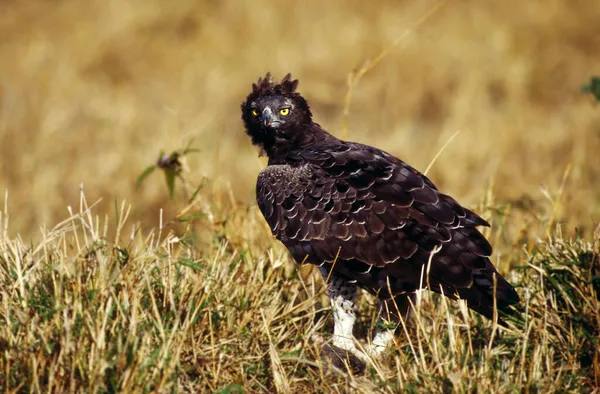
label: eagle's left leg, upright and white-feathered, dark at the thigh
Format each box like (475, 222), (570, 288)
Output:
(319, 267), (366, 360)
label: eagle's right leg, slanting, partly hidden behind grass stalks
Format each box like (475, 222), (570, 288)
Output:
(365, 293), (416, 358)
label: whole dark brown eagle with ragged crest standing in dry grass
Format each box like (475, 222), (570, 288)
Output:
(241, 73), (519, 361)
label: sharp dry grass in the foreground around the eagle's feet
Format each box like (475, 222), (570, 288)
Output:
(0, 189), (600, 393)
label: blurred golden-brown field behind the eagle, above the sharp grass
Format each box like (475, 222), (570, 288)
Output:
(0, 0), (600, 249)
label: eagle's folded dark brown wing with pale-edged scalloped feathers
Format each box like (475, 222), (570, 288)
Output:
(256, 143), (518, 315)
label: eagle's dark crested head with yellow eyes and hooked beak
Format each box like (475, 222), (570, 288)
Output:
(242, 73), (312, 153)
